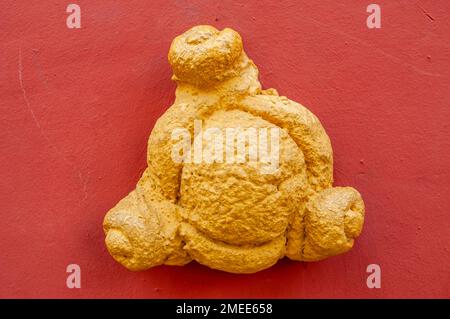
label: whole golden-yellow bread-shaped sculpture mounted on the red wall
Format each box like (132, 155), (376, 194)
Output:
(103, 25), (364, 273)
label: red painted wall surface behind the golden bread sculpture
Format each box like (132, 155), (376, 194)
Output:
(0, 0), (450, 298)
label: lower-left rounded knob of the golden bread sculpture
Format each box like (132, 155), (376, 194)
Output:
(103, 169), (191, 270)
